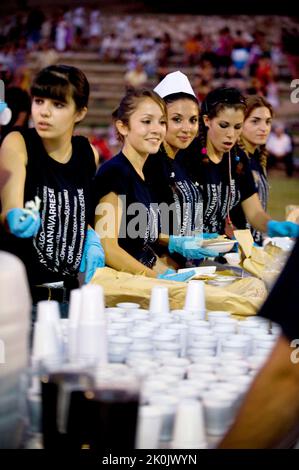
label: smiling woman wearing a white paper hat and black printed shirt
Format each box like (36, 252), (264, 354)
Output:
(144, 71), (217, 264)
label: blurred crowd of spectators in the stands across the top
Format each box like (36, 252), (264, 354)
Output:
(0, 6), (299, 167)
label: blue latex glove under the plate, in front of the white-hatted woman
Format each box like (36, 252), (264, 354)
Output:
(168, 235), (219, 259)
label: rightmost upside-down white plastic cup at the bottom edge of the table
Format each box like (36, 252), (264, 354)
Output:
(171, 399), (207, 449)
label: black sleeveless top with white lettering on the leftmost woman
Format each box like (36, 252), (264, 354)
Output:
(0, 129), (96, 284)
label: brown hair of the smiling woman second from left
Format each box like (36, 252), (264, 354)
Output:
(112, 88), (167, 142)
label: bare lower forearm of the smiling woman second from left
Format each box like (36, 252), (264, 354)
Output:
(102, 244), (157, 277)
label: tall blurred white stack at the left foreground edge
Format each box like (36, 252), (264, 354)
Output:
(0, 251), (31, 449)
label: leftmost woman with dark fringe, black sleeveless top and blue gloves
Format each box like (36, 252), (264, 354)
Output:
(0, 65), (104, 298)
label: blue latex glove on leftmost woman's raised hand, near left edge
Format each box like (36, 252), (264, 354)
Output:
(6, 208), (41, 238)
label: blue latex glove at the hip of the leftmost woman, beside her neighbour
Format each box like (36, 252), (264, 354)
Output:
(80, 228), (105, 284)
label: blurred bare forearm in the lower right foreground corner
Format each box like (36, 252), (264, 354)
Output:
(219, 337), (299, 449)
